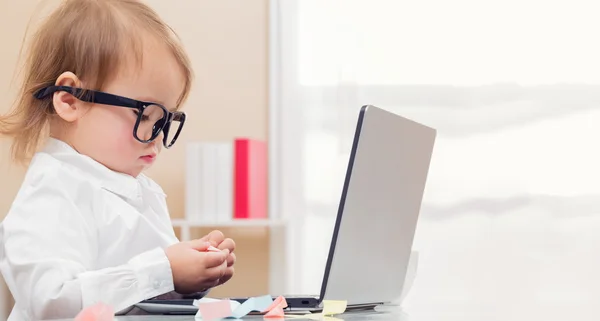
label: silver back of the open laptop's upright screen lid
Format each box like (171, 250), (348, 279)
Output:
(319, 106), (436, 305)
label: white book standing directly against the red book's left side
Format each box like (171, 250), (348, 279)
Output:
(216, 141), (234, 223)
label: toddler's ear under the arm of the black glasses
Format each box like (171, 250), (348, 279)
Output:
(52, 71), (85, 122)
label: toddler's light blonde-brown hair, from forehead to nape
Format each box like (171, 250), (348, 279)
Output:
(0, 0), (192, 162)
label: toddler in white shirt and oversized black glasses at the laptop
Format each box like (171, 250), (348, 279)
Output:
(0, 0), (235, 320)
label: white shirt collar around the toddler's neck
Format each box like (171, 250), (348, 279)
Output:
(42, 138), (142, 199)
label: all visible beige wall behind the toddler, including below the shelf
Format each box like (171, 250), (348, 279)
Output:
(0, 0), (269, 318)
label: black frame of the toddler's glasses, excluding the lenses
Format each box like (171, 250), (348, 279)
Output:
(33, 86), (186, 149)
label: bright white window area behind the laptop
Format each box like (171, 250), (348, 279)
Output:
(277, 0), (600, 320)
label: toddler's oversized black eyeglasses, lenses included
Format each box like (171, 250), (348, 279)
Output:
(33, 86), (185, 148)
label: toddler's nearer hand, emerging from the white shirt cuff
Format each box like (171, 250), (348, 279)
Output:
(165, 239), (231, 294)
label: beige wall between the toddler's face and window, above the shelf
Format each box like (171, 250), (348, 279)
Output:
(146, 0), (268, 217)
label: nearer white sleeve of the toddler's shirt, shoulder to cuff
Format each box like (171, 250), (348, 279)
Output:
(0, 176), (174, 320)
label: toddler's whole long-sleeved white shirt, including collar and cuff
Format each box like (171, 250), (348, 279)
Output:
(0, 139), (178, 320)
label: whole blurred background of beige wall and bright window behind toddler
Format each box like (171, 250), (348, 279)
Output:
(0, 0), (600, 320)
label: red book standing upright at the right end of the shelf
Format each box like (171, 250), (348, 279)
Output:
(233, 138), (268, 219)
